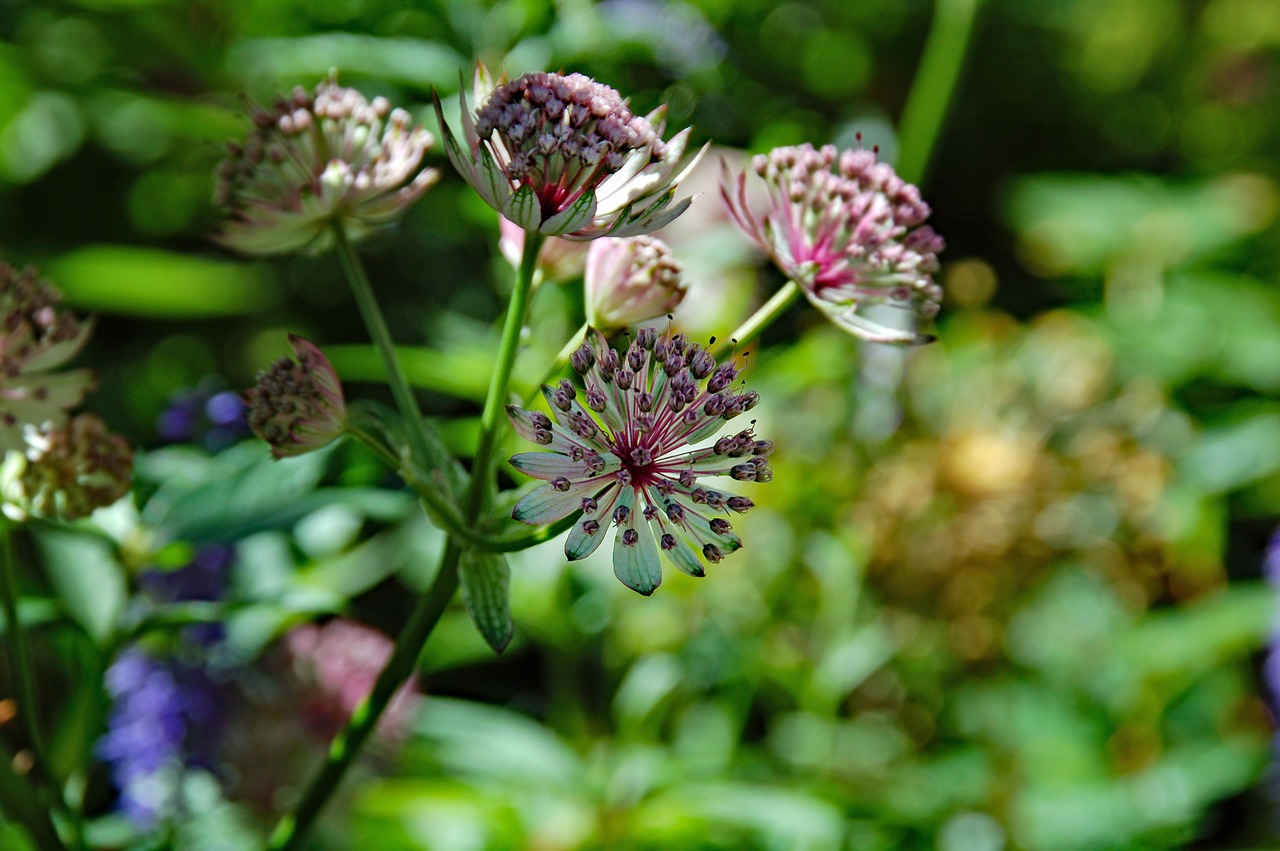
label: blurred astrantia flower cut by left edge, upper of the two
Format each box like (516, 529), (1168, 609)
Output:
(0, 262), (93, 452)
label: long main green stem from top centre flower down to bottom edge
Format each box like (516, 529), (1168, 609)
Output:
(268, 232), (544, 851)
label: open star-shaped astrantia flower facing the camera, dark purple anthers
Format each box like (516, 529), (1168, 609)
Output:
(507, 322), (773, 594)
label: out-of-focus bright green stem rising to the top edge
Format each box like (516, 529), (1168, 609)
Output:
(895, 0), (982, 183)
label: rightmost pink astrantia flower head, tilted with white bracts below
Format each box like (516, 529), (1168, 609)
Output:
(721, 145), (943, 343)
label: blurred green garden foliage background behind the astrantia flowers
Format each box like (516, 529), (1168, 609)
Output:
(0, 0), (1280, 851)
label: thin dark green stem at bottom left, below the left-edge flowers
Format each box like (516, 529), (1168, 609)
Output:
(0, 520), (84, 848)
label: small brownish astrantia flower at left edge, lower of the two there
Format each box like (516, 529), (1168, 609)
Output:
(0, 413), (133, 521)
